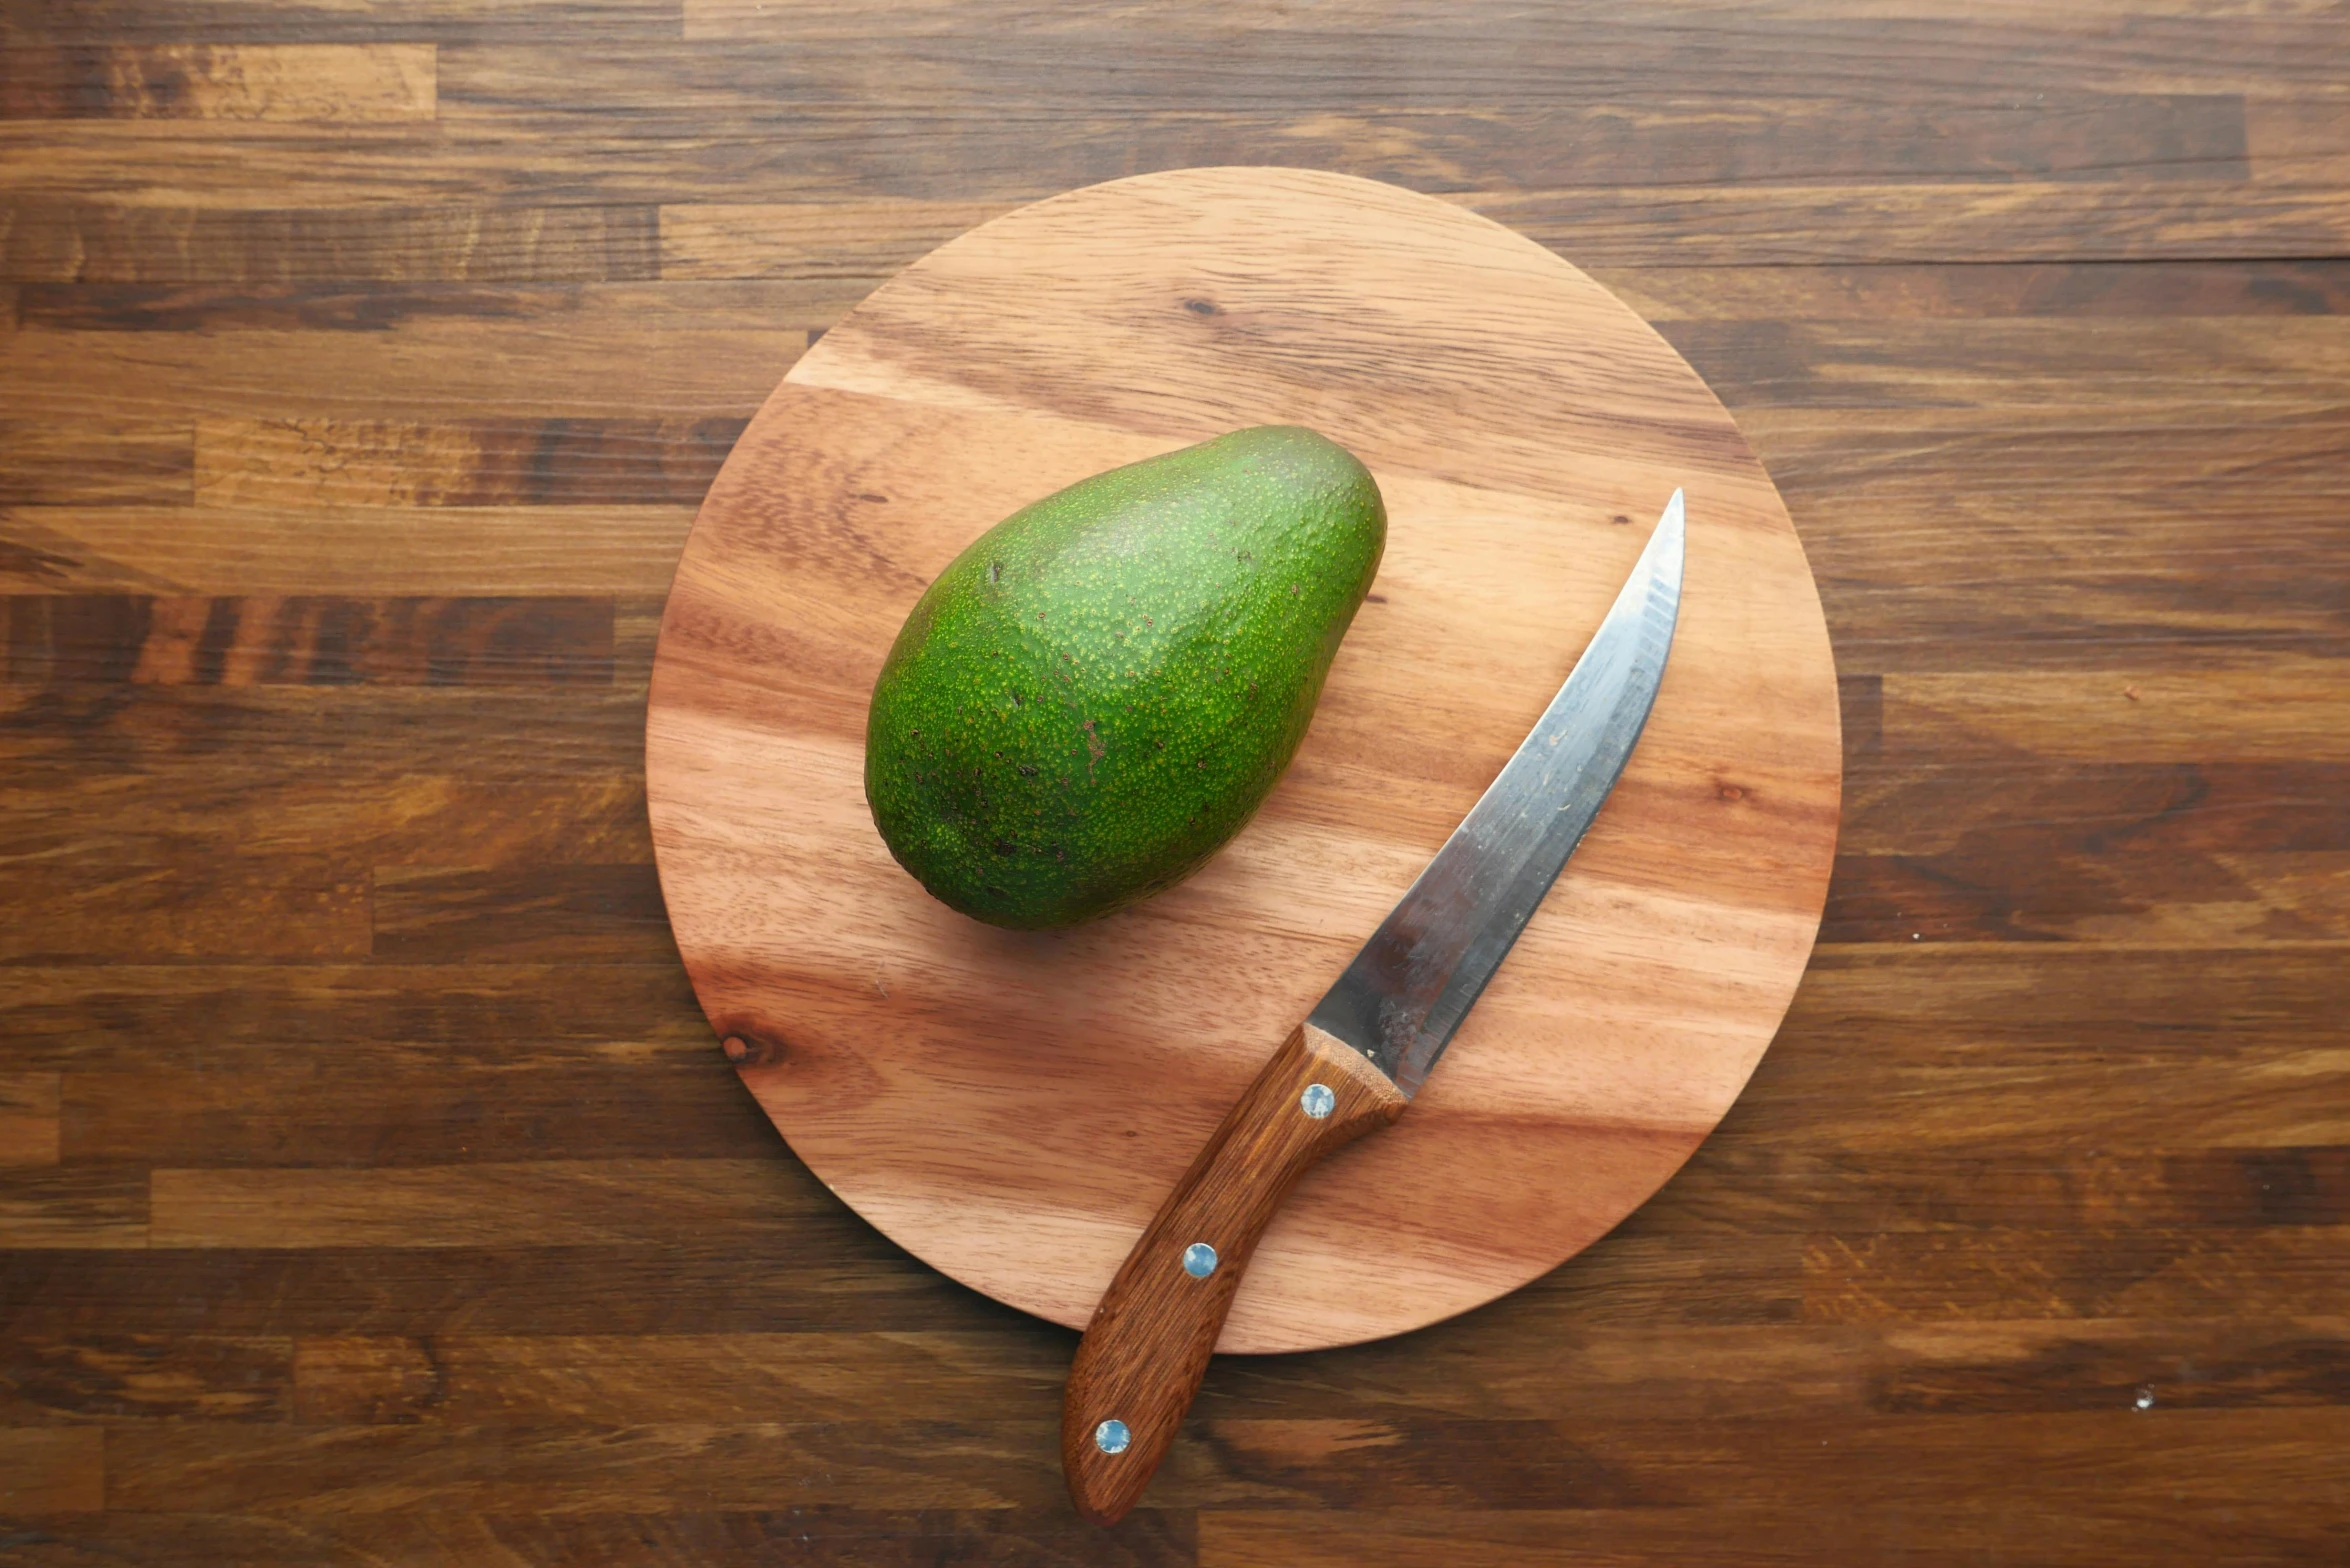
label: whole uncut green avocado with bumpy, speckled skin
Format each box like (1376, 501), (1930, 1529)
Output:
(865, 425), (1387, 931)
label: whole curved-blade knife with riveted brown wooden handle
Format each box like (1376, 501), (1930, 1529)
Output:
(1060, 489), (1683, 1523)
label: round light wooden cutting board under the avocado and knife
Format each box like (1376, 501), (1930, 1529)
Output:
(646, 169), (1840, 1352)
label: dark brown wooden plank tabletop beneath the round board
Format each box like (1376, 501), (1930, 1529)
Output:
(0, 0), (2350, 1568)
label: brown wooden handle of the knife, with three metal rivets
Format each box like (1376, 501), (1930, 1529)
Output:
(1060, 1023), (1410, 1523)
